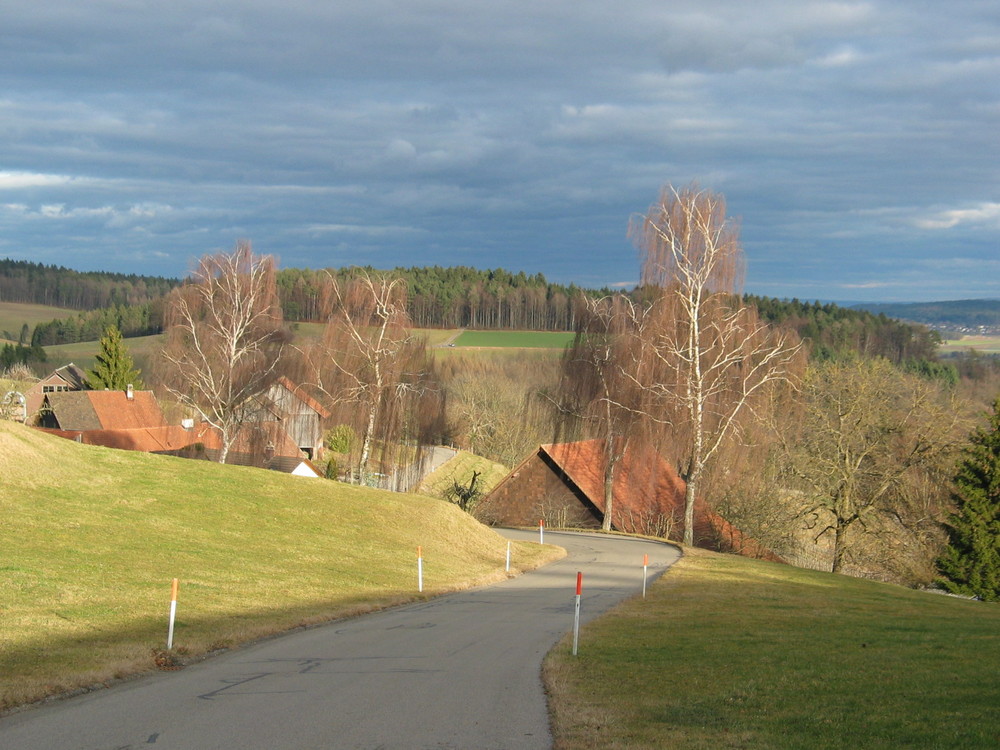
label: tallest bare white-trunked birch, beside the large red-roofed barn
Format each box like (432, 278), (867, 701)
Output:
(630, 185), (800, 544)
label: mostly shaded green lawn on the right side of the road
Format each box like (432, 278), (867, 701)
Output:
(545, 550), (1000, 750)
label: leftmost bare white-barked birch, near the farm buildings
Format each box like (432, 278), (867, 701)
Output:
(161, 241), (286, 463)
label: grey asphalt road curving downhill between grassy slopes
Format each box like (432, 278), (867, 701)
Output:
(0, 531), (678, 750)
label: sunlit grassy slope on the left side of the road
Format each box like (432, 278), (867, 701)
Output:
(0, 422), (559, 709)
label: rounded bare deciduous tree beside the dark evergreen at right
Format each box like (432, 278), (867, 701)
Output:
(781, 360), (968, 573)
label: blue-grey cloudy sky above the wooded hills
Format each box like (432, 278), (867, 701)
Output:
(0, 0), (1000, 301)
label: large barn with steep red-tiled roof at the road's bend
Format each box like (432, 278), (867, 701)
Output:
(475, 440), (780, 561)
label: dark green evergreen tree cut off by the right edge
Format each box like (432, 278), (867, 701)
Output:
(938, 398), (1000, 601)
